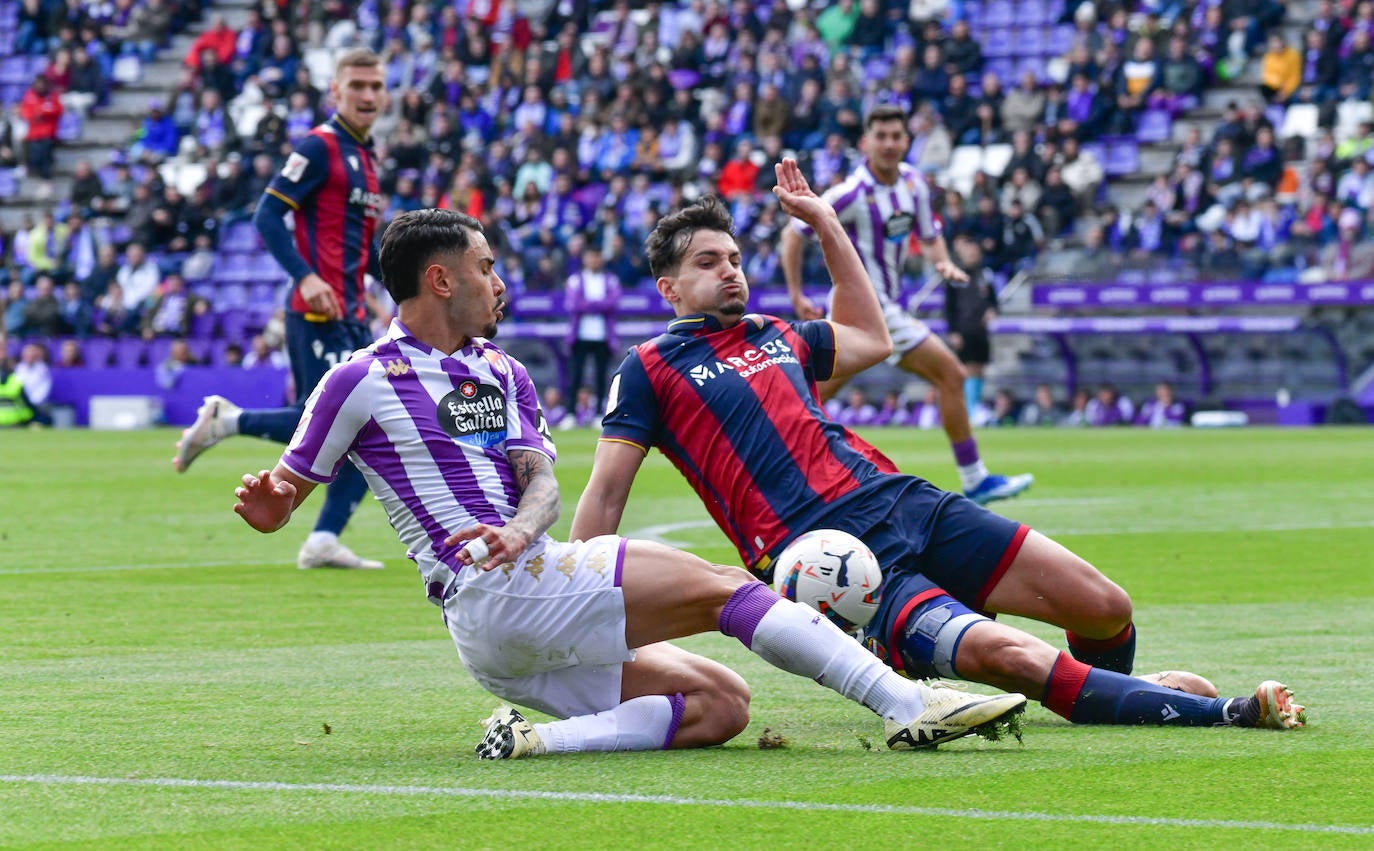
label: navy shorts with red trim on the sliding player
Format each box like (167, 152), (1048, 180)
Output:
(855, 477), (1031, 667)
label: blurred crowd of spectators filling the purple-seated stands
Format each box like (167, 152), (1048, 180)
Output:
(0, 0), (1374, 390)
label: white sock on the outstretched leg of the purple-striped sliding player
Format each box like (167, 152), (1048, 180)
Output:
(749, 599), (926, 723)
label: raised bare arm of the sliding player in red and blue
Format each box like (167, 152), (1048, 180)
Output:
(774, 158), (892, 377)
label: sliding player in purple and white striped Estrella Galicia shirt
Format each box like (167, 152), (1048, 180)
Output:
(234, 210), (1025, 759)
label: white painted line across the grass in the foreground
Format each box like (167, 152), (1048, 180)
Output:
(0, 774), (1374, 836)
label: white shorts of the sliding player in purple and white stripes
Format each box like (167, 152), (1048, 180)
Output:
(444, 535), (635, 718)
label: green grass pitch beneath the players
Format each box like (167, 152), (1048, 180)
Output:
(0, 429), (1374, 848)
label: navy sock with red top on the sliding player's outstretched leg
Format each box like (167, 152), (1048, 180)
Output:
(1040, 653), (1231, 727)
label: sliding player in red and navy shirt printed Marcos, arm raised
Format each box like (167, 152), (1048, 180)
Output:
(572, 159), (1303, 730)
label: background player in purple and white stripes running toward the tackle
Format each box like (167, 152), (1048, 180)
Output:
(778, 106), (1035, 505)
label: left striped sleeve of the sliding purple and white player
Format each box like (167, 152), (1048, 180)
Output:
(282, 357), (374, 484)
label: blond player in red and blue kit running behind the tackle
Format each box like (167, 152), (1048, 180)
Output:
(173, 49), (386, 569)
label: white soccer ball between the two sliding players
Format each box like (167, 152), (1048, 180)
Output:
(774, 529), (882, 632)
